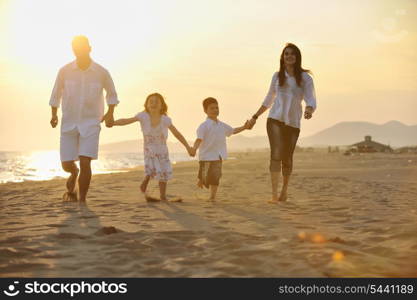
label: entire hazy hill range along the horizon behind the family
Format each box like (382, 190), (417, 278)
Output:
(100, 121), (417, 153)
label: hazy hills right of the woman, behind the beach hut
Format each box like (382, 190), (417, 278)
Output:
(299, 121), (417, 147)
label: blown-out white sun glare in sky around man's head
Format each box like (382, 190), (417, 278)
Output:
(8, 0), (161, 69)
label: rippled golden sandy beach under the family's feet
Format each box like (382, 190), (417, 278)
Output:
(0, 152), (417, 277)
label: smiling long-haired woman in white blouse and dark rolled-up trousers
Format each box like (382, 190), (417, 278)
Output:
(249, 43), (316, 203)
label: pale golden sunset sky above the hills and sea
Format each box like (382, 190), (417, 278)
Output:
(0, 0), (417, 151)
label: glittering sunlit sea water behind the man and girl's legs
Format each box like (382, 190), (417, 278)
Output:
(0, 151), (193, 183)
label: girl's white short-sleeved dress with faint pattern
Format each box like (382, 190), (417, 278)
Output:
(136, 111), (172, 181)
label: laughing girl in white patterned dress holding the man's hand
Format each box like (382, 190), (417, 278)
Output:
(113, 93), (192, 201)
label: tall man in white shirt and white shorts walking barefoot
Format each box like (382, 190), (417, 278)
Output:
(49, 36), (119, 202)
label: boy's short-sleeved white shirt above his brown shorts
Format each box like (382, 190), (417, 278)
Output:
(197, 118), (233, 161)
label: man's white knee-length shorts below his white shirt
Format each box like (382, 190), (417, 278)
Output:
(60, 128), (100, 161)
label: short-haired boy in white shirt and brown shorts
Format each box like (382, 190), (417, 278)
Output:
(191, 97), (249, 201)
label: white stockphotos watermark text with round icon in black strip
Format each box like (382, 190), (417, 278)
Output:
(3, 280), (127, 297)
